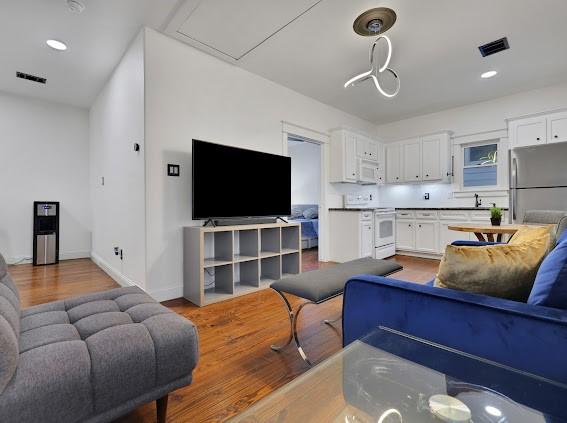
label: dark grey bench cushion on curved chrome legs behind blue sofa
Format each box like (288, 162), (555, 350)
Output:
(270, 257), (402, 303)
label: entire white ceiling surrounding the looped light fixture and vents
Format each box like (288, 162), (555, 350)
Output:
(0, 0), (567, 123)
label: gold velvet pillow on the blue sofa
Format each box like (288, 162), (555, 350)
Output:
(435, 234), (550, 302)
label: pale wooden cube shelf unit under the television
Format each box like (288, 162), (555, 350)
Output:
(183, 223), (301, 306)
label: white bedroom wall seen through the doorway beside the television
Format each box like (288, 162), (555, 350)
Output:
(287, 142), (321, 204)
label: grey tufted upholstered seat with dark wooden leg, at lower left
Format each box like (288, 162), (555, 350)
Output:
(0, 255), (198, 423)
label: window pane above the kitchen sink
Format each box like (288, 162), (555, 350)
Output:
(463, 143), (498, 188)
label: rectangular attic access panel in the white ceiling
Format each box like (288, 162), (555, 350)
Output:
(171, 0), (321, 61)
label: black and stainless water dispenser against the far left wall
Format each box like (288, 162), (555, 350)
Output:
(33, 201), (59, 266)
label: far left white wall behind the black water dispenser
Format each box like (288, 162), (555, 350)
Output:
(0, 92), (91, 262)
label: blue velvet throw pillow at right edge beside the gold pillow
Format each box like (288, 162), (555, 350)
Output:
(528, 235), (567, 310)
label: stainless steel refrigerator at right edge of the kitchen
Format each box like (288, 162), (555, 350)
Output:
(509, 143), (567, 223)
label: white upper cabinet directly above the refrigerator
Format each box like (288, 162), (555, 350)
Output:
(508, 111), (567, 148)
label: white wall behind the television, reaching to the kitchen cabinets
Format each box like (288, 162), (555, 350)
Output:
(146, 30), (376, 299)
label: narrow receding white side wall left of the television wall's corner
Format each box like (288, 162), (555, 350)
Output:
(90, 31), (146, 287)
